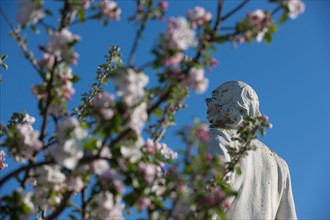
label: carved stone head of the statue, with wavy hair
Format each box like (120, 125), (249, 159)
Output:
(205, 81), (261, 129)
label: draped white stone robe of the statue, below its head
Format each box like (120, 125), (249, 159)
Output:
(207, 128), (297, 220)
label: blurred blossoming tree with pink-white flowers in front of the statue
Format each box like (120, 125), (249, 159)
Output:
(0, 0), (304, 219)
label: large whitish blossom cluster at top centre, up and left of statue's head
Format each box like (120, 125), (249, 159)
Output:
(164, 17), (195, 50)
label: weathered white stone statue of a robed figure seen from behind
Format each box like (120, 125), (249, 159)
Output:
(206, 81), (297, 220)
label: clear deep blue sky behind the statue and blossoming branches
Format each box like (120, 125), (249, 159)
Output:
(0, 0), (330, 219)
